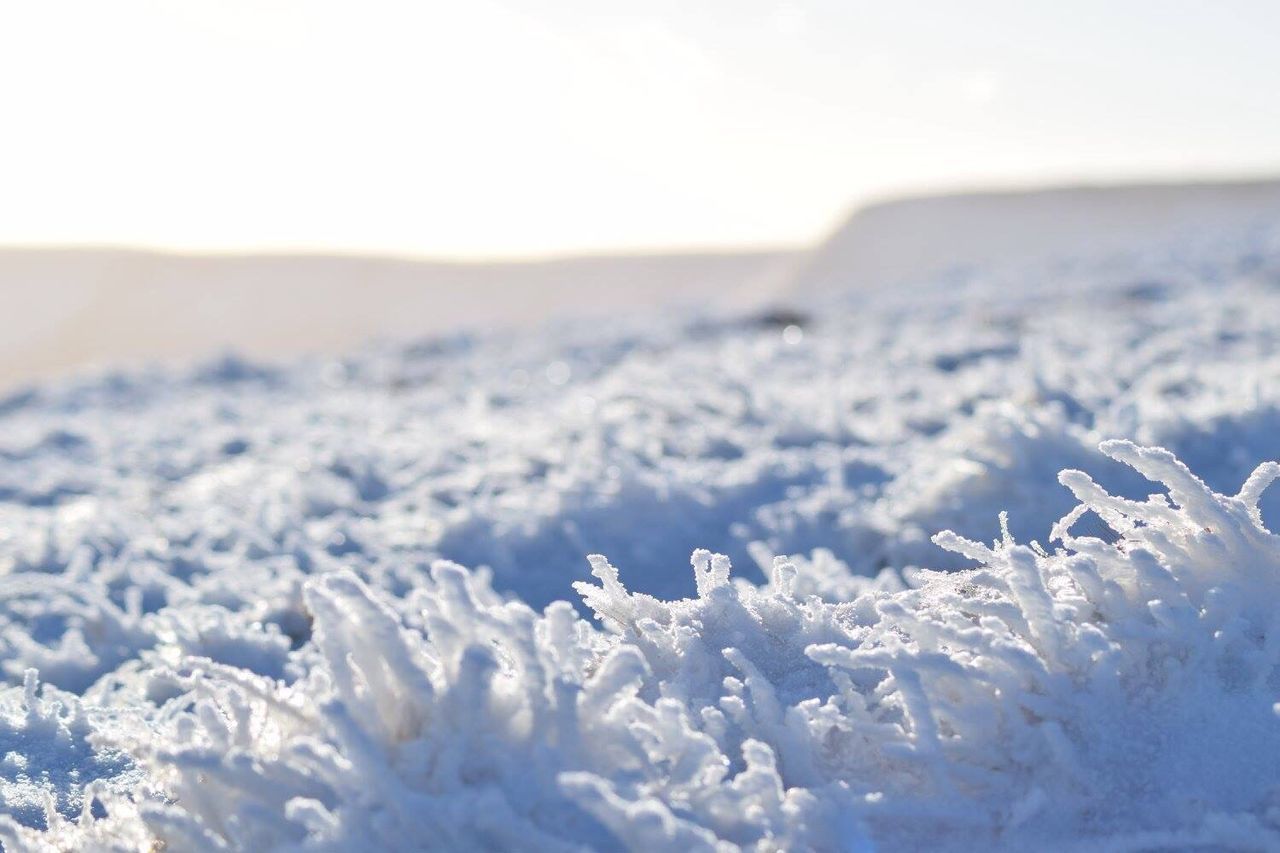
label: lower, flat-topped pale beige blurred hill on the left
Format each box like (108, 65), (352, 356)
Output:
(0, 248), (795, 386)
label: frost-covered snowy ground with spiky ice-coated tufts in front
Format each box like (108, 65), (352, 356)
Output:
(0, 219), (1280, 850)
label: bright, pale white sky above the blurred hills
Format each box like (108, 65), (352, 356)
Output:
(0, 0), (1280, 259)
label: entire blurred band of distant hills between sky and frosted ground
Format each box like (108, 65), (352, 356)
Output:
(0, 179), (1280, 389)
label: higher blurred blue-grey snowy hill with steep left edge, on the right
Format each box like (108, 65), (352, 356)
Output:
(788, 181), (1280, 300)
